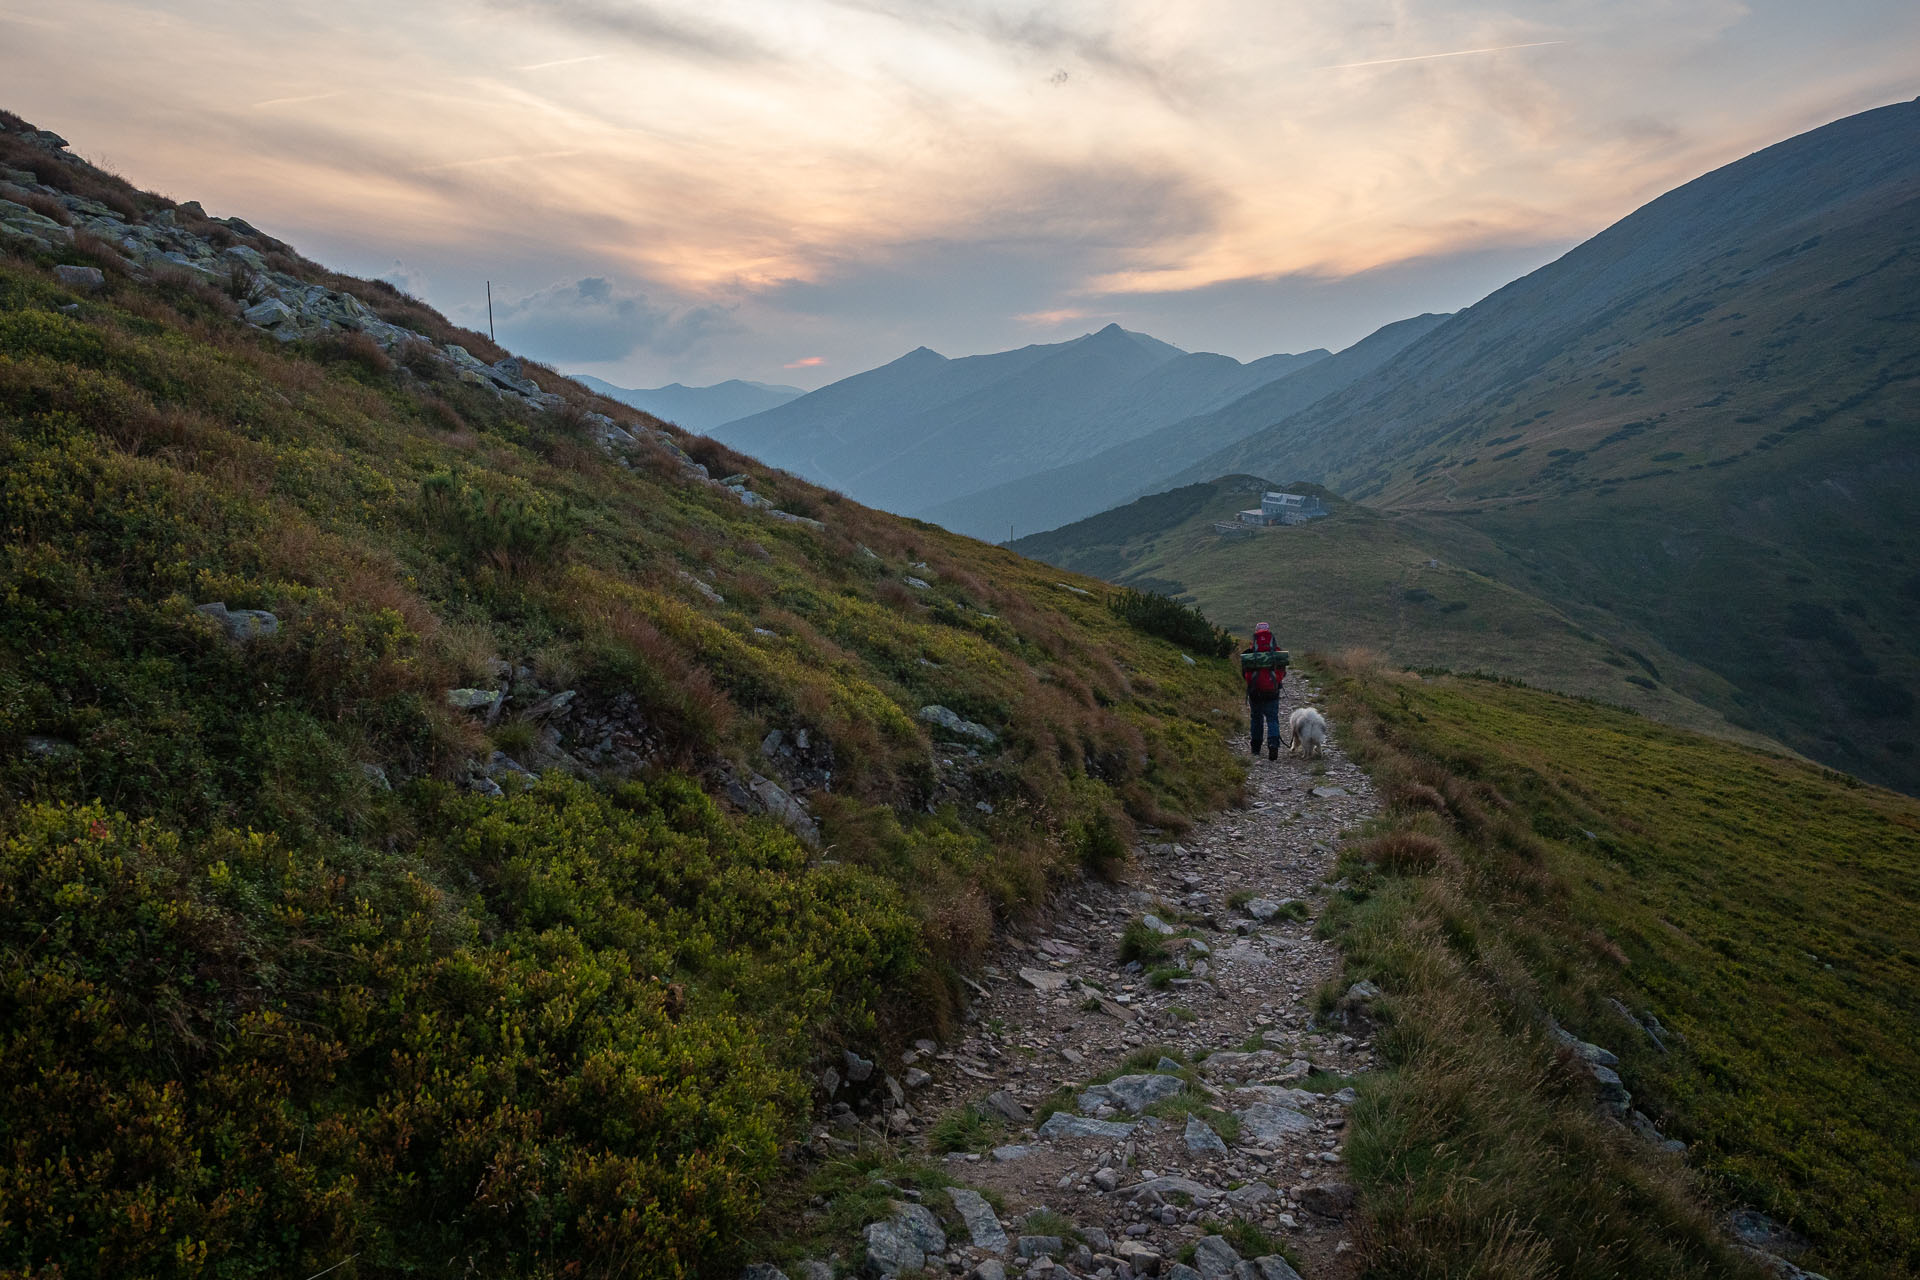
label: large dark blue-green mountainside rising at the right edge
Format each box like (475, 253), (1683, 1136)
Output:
(1188, 104), (1920, 791)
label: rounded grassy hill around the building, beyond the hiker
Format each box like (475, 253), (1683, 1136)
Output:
(1008, 476), (1761, 741)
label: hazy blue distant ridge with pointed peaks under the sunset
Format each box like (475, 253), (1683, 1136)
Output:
(712, 324), (1327, 512)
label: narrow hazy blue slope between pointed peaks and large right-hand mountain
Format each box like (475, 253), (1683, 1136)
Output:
(914, 315), (1446, 541)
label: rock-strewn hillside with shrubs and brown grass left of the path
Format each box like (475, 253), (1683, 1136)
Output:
(0, 115), (1238, 1276)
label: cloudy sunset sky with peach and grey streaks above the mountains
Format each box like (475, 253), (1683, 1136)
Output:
(0, 0), (1920, 388)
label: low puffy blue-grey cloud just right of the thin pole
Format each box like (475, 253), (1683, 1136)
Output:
(493, 276), (739, 365)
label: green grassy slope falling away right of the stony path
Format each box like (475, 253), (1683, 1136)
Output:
(1327, 664), (1920, 1276)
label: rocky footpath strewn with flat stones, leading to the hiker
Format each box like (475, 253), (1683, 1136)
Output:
(856, 676), (1377, 1280)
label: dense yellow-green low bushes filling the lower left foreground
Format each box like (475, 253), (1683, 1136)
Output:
(0, 779), (918, 1276)
